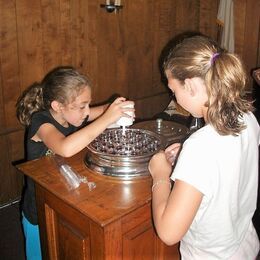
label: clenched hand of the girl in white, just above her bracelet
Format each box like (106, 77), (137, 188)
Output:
(148, 151), (172, 180)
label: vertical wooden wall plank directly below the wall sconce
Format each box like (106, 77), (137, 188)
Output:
(95, 2), (128, 100)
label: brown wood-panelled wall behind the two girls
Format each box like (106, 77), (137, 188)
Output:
(0, 0), (259, 205)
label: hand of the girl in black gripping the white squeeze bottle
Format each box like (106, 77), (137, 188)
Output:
(103, 97), (135, 124)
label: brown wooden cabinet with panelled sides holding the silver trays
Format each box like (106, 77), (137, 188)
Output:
(18, 151), (179, 260)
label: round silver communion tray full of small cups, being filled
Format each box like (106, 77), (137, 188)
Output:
(84, 128), (165, 179)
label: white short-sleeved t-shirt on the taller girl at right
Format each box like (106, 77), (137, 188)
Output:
(171, 113), (260, 260)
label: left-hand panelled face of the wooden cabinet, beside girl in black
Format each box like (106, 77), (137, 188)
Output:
(36, 185), (91, 260)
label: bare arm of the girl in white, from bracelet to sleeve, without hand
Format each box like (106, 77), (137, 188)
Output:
(152, 180), (202, 245)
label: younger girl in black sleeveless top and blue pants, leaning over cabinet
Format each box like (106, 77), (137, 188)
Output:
(17, 67), (134, 260)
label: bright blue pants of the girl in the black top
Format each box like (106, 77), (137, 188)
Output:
(22, 215), (42, 260)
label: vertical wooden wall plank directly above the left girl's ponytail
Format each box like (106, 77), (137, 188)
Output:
(16, 0), (44, 90)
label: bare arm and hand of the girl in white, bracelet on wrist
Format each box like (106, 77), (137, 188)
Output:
(149, 152), (203, 245)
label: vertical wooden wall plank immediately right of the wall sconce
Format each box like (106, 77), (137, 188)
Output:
(126, 0), (156, 99)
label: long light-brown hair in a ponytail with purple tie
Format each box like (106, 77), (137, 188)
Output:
(164, 36), (253, 135)
